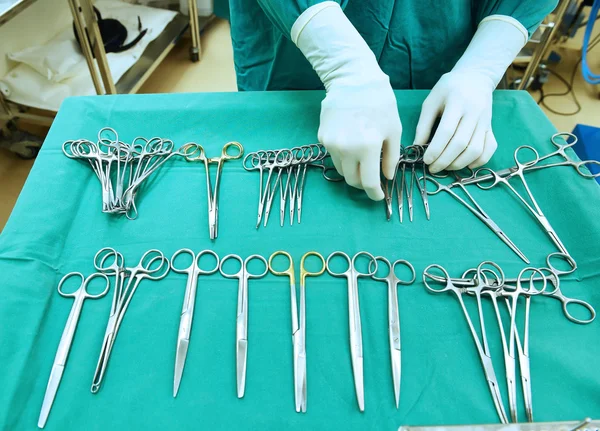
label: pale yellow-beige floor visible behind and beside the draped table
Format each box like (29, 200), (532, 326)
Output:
(0, 20), (600, 229)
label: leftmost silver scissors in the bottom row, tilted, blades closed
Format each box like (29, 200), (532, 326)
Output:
(38, 272), (110, 428)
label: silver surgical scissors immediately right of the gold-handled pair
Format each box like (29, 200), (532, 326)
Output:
(325, 251), (377, 412)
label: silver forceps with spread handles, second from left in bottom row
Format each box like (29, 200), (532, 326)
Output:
(91, 247), (170, 394)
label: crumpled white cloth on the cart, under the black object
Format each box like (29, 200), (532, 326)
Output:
(0, 0), (177, 111)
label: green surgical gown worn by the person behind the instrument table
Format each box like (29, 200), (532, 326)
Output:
(229, 0), (557, 90)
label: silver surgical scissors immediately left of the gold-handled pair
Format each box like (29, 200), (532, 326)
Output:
(219, 254), (269, 398)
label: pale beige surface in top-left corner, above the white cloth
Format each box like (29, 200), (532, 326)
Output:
(0, 0), (72, 77)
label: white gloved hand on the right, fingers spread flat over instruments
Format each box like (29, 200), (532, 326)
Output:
(414, 15), (528, 173)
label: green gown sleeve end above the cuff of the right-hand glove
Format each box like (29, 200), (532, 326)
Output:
(476, 0), (558, 37)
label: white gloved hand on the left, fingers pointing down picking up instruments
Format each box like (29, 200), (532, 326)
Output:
(291, 2), (402, 200)
